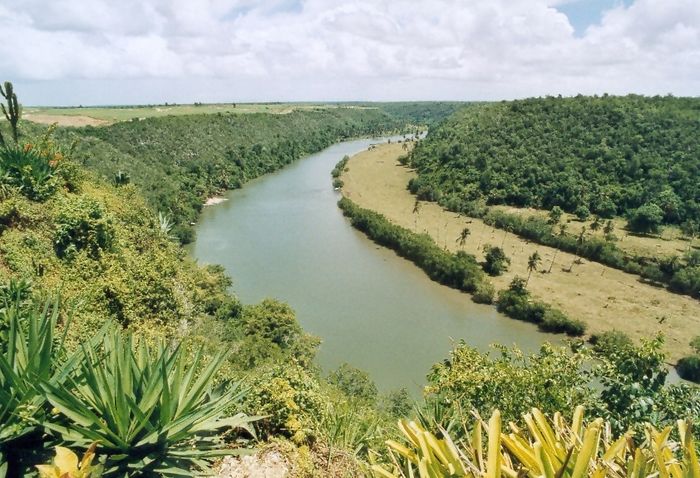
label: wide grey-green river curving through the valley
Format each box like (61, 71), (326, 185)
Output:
(190, 138), (561, 393)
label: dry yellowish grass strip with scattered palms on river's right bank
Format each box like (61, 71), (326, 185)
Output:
(342, 144), (700, 361)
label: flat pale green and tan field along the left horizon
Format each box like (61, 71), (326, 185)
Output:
(24, 103), (360, 126)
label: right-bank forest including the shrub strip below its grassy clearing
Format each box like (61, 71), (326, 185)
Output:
(406, 96), (700, 297)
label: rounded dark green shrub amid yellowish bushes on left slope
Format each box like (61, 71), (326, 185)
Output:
(54, 196), (113, 259)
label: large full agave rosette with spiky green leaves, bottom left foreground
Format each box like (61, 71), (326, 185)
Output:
(42, 328), (255, 476)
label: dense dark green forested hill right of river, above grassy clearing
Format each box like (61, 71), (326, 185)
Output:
(410, 96), (700, 227)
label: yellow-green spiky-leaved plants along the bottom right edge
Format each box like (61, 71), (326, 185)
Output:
(371, 407), (700, 478)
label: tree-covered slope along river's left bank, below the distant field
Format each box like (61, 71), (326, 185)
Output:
(37, 107), (404, 242)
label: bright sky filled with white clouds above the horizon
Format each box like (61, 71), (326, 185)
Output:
(0, 0), (700, 105)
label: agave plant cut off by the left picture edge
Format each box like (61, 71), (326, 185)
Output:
(0, 293), (77, 476)
